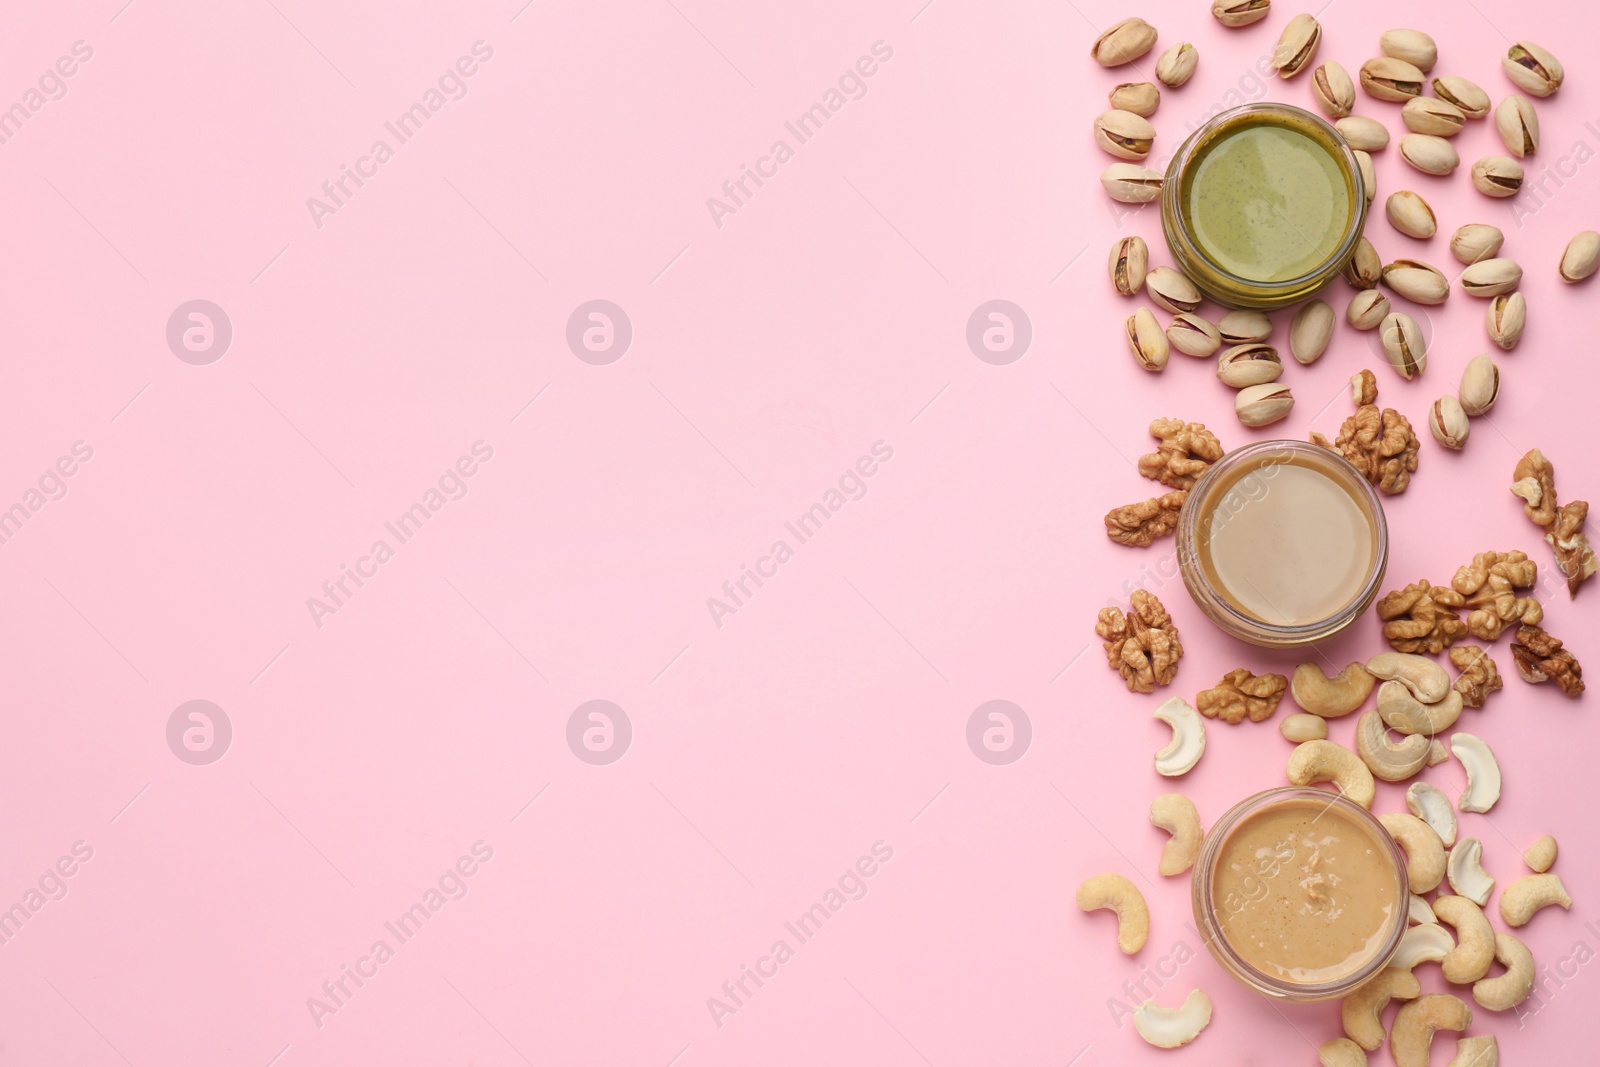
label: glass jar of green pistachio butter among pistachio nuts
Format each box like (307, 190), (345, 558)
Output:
(1162, 104), (1368, 310)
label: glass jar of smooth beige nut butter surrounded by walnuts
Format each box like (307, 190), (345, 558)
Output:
(1178, 440), (1389, 648)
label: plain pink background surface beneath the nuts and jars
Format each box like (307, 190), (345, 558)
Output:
(0, 0), (1600, 1067)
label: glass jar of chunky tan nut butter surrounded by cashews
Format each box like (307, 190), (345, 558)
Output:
(1190, 785), (1410, 1003)
